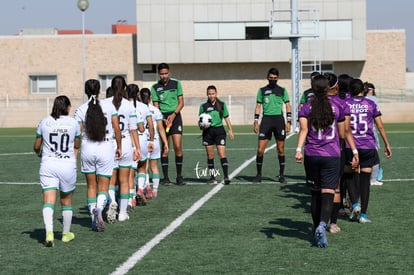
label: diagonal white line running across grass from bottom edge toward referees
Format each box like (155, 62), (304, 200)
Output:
(112, 133), (294, 275)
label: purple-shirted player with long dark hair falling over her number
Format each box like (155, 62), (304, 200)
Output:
(296, 75), (358, 247)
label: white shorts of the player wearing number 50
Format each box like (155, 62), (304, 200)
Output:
(39, 158), (76, 193)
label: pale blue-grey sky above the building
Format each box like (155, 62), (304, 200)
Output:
(0, 0), (414, 71)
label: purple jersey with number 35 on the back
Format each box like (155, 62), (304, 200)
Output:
(346, 96), (381, 149)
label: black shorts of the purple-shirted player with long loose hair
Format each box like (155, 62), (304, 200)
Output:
(304, 156), (341, 189)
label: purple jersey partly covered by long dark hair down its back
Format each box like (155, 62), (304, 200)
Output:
(299, 101), (345, 157)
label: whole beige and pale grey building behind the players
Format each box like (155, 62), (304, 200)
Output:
(0, 0), (414, 127)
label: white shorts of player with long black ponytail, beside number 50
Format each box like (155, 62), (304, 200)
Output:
(81, 141), (115, 178)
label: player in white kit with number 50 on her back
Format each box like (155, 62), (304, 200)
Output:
(33, 95), (80, 247)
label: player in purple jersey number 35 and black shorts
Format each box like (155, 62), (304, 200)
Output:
(345, 79), (392, 223)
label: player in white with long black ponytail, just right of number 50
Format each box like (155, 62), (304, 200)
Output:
(75, 79), (122, 232)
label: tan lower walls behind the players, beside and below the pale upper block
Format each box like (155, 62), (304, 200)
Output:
(0, 30), (414, 127)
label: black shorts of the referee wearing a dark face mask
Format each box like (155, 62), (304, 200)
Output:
(259, 115), (286, 140)
